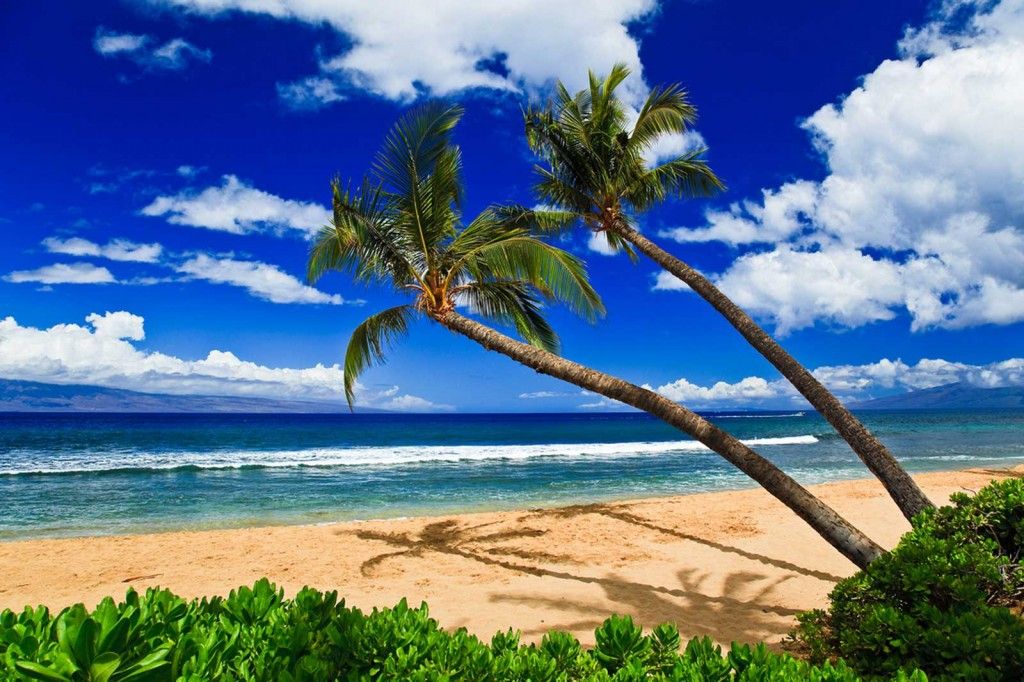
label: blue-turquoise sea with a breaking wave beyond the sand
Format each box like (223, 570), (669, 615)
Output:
(0, 411), (1024, 540)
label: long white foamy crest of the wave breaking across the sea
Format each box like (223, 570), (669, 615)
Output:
(0, 435), (818, 476)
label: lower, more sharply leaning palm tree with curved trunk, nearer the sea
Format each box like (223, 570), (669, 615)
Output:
(308, 100), (882, 567)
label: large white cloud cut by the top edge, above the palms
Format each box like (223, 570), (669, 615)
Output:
(142, 0), (656, 103)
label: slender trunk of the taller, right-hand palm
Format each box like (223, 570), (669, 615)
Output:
(611, 223), (934, 519)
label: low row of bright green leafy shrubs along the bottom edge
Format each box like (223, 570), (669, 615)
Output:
(0, 580), (927, 682)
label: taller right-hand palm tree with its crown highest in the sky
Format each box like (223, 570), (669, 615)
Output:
(516, 65), (932, 518)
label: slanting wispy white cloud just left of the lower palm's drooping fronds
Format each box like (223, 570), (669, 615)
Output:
(175, 254), (352, 305)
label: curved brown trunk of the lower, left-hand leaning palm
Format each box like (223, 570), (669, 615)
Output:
(435, 311), (883, 568)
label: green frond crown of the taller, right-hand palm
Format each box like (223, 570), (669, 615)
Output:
(524, 65), (724, 258)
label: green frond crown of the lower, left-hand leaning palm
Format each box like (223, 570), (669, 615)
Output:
(307, 103), (604, 406)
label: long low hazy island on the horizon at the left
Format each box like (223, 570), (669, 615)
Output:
(0, 379), (356, 414)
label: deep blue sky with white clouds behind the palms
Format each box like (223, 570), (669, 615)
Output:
(0, 0), (1024, 411)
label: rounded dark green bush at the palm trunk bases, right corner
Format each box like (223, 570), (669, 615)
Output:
(798, 479), (1024, 680)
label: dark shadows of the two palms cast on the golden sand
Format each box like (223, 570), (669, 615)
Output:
(339, 504), (841, 642)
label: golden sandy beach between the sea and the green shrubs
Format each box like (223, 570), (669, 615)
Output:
(0, 467), (1024, 643)
